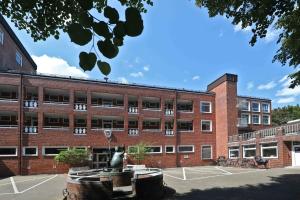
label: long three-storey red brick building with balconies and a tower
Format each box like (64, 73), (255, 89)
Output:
(0, 14), (298, 176)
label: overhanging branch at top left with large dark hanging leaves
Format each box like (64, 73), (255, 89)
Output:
(0, 0), (153, 76)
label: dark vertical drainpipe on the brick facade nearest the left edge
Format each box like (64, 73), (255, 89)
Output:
(18, 73), (23, 175)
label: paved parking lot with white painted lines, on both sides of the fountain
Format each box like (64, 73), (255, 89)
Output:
(0, 166), (300, 200)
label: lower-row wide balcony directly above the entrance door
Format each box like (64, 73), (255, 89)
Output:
(92, 116), (124, 131)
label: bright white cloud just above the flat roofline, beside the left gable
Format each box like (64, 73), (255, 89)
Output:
(32, 55), (89, 78)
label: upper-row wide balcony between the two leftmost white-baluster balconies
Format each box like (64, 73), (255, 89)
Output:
(44, 89), (70, 105)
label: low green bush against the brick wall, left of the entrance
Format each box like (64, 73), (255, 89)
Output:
(54, 149), (89, 166)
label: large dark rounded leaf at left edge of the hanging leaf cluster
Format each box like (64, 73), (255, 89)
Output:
(68, 23), (92, 46)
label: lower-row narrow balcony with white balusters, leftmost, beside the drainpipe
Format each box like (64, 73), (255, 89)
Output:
(23, 112), (38, 134)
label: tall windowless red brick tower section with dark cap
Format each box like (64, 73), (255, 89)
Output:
(207, 74), (238, 158)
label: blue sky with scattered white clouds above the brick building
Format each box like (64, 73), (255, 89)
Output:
(5, 0), (300, 107)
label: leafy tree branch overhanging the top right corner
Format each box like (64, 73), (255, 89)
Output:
(196, 0), (300, 88)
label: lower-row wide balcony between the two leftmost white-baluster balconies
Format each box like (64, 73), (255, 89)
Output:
(43, 113), (69, 130)
